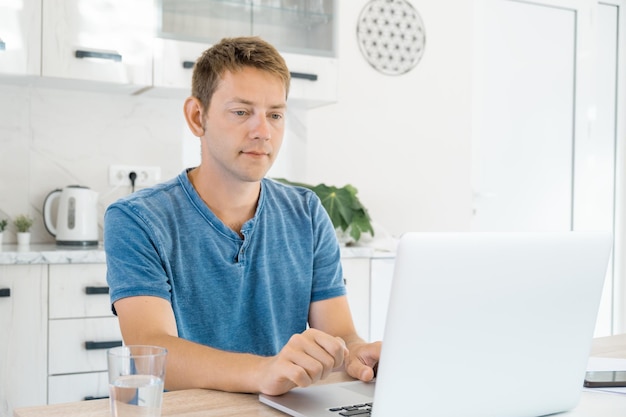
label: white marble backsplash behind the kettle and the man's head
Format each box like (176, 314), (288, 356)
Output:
(0, 85), (306, 244)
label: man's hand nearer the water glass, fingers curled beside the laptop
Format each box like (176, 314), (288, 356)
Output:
(259, 329), (349, 395)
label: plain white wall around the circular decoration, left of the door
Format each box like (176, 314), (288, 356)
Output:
(306, 0), (473, 235)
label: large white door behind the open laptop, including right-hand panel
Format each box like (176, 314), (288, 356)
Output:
(472, 0), (619, 335)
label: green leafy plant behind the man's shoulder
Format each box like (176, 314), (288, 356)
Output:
(275, 178), (374, 242)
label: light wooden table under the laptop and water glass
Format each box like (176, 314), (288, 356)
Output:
(14, 334), (626, 417)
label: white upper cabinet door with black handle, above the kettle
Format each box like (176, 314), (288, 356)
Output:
(42, 0), (156, 87)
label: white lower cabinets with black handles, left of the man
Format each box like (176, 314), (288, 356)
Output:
(0, 263), (122, 417)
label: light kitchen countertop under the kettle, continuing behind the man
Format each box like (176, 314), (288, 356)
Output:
(0, 243), (395, 265)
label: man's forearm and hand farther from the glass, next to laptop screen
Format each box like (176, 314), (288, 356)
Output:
(309, 296), (381, 381)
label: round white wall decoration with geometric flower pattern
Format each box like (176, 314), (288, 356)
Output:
(356, 0), (426, 75)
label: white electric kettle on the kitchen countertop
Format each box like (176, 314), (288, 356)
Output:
(43, 185), (98, 246)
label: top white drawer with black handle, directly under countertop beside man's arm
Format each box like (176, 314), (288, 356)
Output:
(49, 264), (113, 319)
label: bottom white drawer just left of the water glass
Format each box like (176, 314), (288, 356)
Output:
(48, 372), (109, 404)
